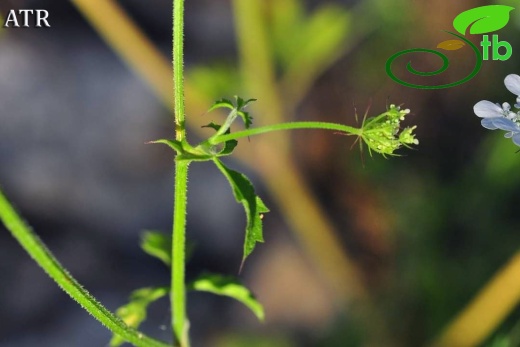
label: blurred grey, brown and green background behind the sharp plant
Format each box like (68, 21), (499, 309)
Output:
(0, 0), (520, 347)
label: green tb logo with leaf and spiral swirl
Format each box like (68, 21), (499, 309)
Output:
(386, 5), (514, 89)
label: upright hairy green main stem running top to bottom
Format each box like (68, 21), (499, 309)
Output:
(170, 0), (189, 347)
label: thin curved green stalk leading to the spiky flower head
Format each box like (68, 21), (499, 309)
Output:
(207, 122), (361, 145)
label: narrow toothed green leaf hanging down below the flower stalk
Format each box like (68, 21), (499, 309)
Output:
(213, 158), (269, 270)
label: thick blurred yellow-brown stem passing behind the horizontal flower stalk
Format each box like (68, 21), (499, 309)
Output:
(233, 0), (392, 346)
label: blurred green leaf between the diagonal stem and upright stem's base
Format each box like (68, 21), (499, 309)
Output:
(110, 287), (170, 347)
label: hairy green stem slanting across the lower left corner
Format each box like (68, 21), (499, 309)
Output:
(0, 191), (168, 347)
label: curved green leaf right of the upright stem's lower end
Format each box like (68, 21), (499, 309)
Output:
(189, 274), (265, 321)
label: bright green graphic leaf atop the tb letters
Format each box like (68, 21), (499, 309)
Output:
(453, 5), (514, 35)
